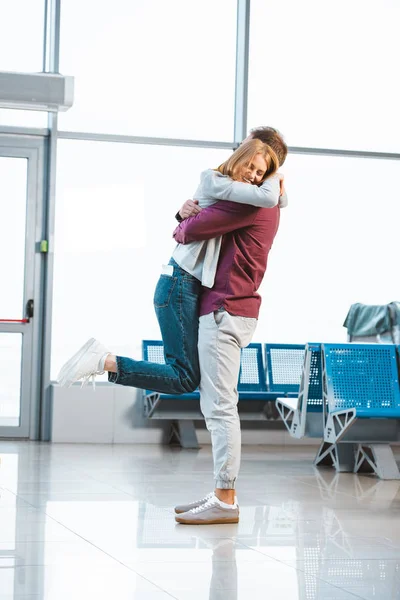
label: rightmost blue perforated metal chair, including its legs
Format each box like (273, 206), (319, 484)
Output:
(322, 344), (400, 479)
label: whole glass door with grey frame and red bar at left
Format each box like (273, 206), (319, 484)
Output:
(0, 135), (45, 438)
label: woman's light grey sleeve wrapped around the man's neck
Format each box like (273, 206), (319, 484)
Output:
(202, 169), (280, 208)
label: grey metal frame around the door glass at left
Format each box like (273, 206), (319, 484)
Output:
(0, 133), (48, 439)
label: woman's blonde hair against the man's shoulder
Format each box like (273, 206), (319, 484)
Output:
(215, 139), (279, 181)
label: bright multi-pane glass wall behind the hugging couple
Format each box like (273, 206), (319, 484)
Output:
(0, 0), (400, 376)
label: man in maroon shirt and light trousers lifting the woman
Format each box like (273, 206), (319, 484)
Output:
(174, 128), (287, 524)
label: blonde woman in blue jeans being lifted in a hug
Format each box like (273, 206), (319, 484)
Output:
(58, 139), (286, 394)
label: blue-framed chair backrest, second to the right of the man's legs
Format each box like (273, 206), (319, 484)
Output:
(265, 344), (305, 393)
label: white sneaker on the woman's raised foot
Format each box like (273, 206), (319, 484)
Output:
(57, 338), (110, 388)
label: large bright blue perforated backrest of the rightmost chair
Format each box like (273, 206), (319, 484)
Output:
(322, 344), (400, 417)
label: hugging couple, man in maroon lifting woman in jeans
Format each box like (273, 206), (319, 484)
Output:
(58, 127), (287, 525)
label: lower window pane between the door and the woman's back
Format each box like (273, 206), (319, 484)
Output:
(52, 140), (231, 378)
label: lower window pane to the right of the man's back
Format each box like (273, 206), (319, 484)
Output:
(256, 154), (400, 343)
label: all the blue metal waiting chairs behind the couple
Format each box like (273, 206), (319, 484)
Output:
(143, 340), (400, 479)
